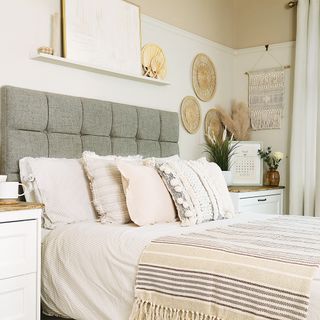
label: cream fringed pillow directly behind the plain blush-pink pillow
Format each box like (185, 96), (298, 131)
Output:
(82, 151), (142, 224)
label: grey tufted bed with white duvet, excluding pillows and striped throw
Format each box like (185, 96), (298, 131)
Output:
(1, 87), (320, 320)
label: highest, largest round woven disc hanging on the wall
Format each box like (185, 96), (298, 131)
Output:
(192, 53), (217, 101)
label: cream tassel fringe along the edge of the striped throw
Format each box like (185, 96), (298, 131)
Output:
(129, 299), (222, 320)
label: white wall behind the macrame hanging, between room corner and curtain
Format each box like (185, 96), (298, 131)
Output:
(233, 42), (294, 209)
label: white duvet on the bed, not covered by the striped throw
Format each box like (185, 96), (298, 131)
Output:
(42, 215), (320, 320)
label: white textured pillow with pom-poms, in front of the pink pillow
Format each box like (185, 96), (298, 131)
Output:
(156, 158), (234, 226)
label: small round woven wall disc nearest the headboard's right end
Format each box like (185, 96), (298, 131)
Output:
(180, 96), (201, 133)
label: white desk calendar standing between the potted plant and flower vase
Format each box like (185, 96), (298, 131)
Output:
(231, 141), (263, 186)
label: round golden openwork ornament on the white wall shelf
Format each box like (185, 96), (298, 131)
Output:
(141, 43), (167, 80)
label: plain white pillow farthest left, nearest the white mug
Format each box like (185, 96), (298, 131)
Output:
(19, 157), (96, 229)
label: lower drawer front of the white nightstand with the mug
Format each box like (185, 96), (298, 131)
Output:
(0, 273), (37, 320)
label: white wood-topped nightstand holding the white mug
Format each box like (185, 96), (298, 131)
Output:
(0, 202), (42, 320)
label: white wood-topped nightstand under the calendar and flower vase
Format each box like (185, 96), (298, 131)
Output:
(229, 186), (284, 214)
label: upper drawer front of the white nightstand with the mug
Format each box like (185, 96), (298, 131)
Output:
(0, 220), (37, 280)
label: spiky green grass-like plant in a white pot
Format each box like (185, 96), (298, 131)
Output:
(205, 127), (237, 186)
